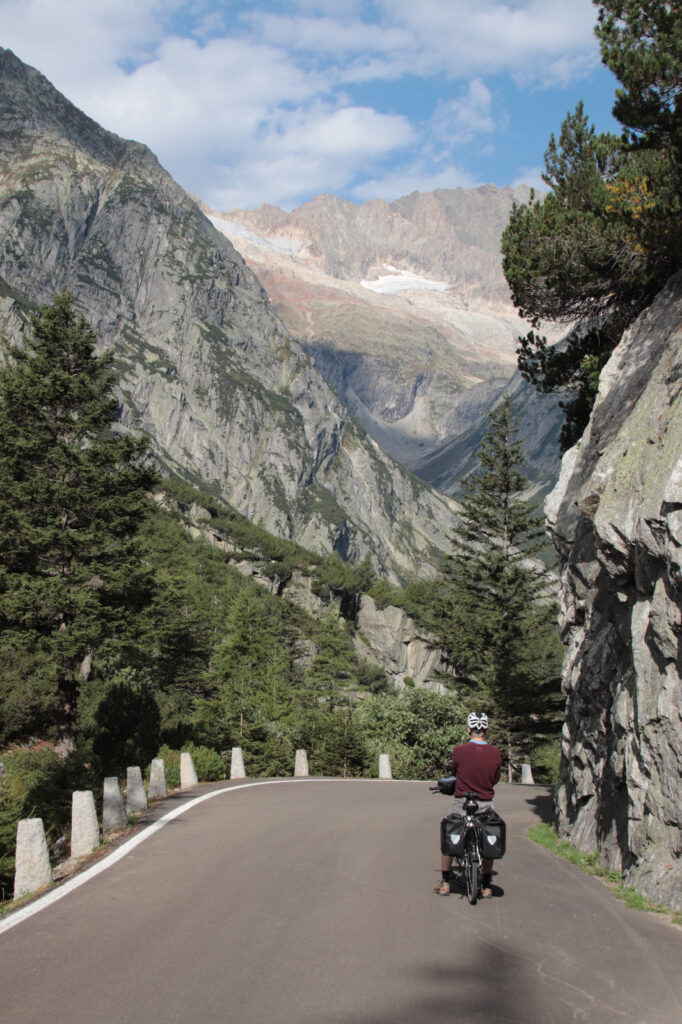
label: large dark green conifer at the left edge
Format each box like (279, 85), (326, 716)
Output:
(0, 294), (154, 738)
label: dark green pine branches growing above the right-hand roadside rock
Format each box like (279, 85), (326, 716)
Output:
(502, 0), (682, 450)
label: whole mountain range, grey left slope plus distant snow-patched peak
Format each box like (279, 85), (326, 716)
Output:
(0, 49), (560, 593)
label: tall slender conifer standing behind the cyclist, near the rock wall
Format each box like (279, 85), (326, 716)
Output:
(440, 396), (561, 779)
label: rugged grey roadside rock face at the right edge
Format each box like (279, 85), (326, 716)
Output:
(546, 274), (682, 909)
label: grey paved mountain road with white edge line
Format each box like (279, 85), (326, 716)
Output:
(0, 780), (682, 1024)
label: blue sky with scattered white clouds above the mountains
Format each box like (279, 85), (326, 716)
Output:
(0, 0), (620, 211)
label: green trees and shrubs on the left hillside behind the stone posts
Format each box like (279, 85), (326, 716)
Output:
(0, 295), (473, 894)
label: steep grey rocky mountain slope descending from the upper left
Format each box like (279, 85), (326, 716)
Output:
(0, 50), (454, 578)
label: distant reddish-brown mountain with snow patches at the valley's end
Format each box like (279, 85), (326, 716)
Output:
(204, 185), (561, 493)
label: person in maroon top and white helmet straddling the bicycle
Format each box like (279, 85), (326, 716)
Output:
(433, 712), (502, 898)
